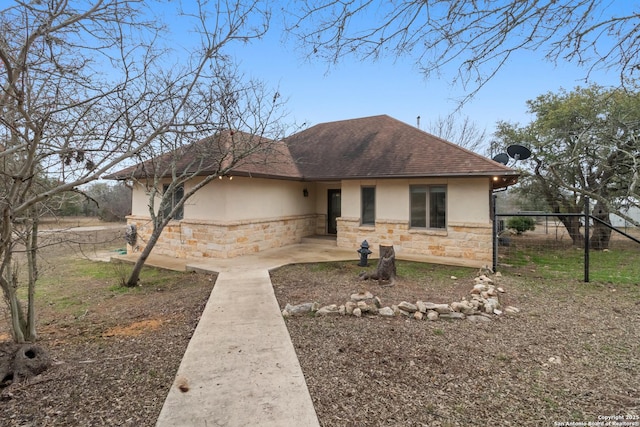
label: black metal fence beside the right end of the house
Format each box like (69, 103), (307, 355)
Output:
(493, 195), (640, 282)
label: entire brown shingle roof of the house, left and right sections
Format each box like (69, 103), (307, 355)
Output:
(109, 115), (519, 187)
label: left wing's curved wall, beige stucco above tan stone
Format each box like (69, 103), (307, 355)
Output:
(128, 177), (326, 258)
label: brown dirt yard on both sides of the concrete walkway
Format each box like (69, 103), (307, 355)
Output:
(0, 222), (640, 427)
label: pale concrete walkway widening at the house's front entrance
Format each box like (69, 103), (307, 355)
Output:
(115, 243), (358, 427)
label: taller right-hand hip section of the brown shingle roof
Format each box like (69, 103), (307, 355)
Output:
(286, 115), (518, 180)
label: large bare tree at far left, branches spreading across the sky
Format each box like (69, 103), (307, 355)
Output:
(0, 0), (270, 342)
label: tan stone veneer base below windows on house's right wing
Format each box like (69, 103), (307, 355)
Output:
(337, 217), (493, 266)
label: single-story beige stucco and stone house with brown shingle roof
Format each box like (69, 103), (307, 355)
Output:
(111, 115), (518, 266)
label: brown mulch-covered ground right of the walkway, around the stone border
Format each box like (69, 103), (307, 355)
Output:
(272, 262), (640, 426)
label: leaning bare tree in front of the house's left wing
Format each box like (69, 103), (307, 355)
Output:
(112, 70), (287, 287)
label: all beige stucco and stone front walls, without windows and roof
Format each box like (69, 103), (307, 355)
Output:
(129, 177), (492, 265)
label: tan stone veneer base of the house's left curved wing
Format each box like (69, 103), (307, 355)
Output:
(127, 214), (321, 258)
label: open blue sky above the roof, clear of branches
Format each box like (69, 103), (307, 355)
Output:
(222, 7), (619, 140)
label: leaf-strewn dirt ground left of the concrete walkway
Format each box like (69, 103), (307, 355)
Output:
(0, 274), (213, 427)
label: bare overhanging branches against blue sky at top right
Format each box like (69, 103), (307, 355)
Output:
(288, 0), (640, 99)
